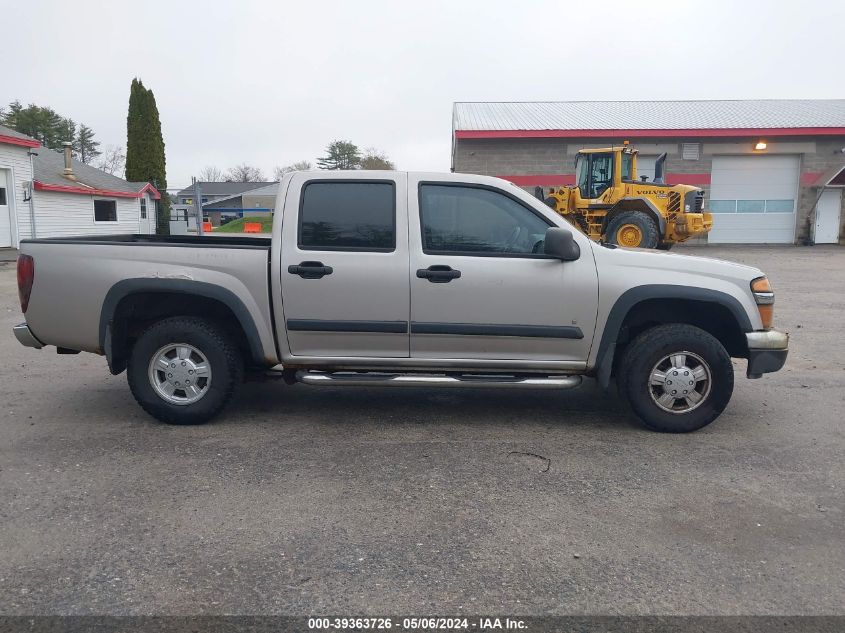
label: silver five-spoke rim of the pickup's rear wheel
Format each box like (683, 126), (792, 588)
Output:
(148, 343), (211, 405)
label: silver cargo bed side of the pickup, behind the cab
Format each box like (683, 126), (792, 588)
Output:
(21, 235), (278, 365)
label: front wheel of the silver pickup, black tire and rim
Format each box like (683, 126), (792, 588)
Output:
(617, 323), (734, 433)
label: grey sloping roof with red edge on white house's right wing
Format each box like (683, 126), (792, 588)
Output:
(32, 147), (161, 199)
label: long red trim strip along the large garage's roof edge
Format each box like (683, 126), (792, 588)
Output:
(455, 127), (845, 139)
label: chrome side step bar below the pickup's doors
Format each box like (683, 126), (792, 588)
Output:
(296, 371), (581, 389)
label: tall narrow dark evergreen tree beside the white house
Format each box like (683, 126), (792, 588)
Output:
(126, 78), (170, 234)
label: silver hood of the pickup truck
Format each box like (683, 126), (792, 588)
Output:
(592, 243), (764, 282)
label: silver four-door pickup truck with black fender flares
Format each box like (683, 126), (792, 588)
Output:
(15, 171), (788, 432)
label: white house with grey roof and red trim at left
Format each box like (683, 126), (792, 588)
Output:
(0, 126), (161, 248)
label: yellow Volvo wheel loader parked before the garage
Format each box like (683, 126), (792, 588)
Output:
(535, 141), (713, 250)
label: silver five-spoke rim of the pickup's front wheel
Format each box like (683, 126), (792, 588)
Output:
(648, 352), (713, 413)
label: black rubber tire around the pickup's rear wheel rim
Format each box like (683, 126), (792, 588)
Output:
(126, 317), (244, 424)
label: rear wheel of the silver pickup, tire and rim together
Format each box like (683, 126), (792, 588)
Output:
(127, 317), (243, 424)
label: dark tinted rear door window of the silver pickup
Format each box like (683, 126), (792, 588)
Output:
(297, 180), (396, 252)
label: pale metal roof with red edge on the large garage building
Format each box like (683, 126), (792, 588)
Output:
(452, 99), (845, 138)
